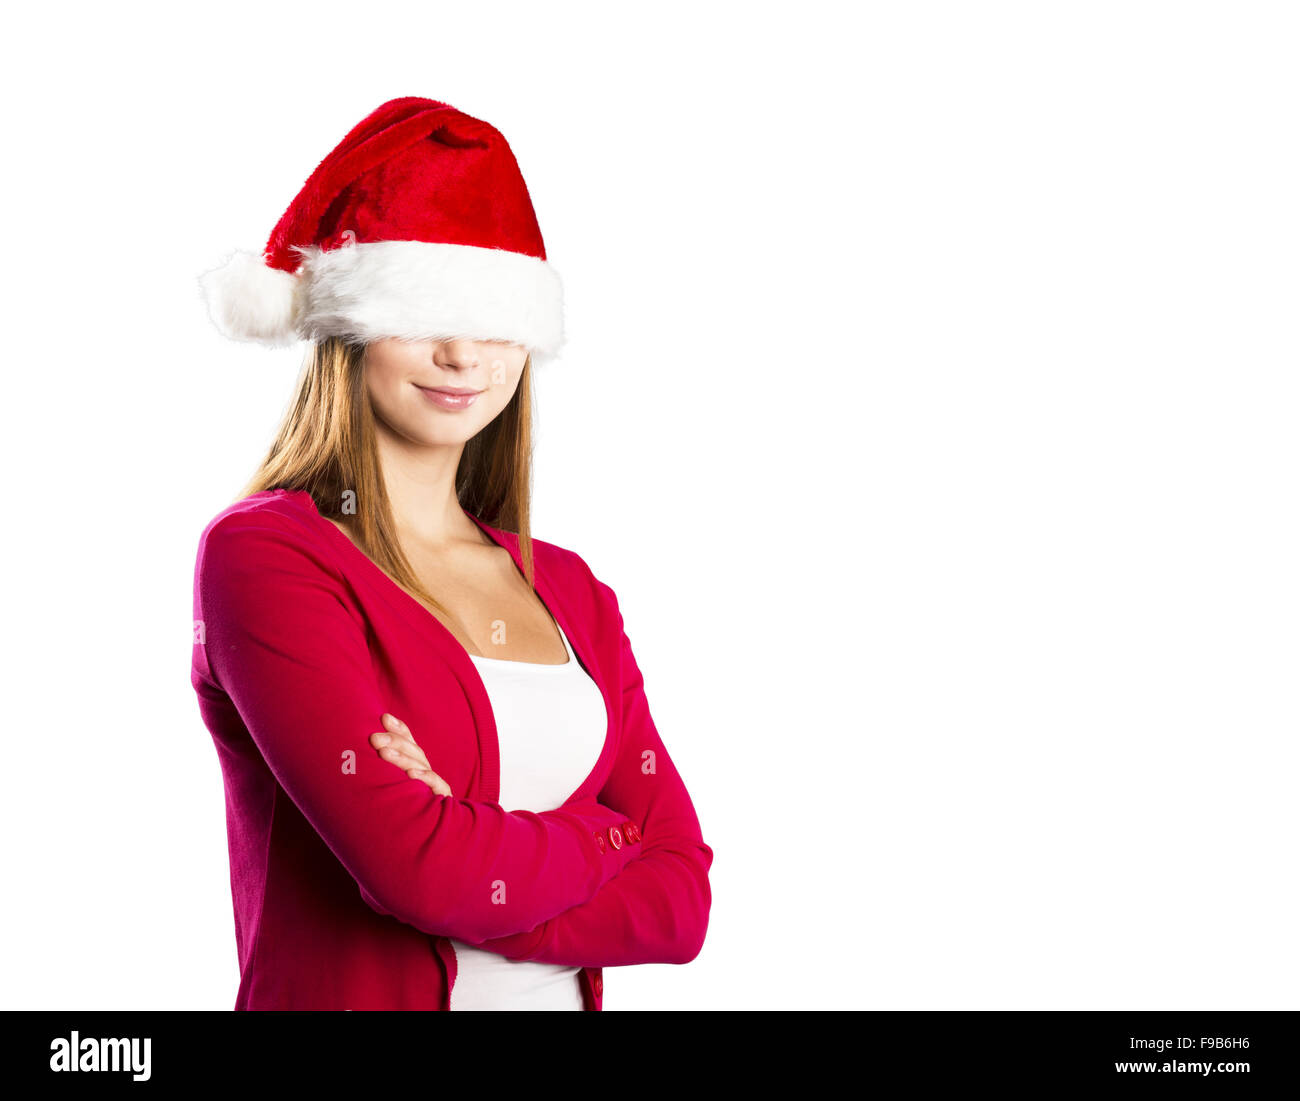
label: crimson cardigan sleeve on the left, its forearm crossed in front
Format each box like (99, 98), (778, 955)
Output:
(195, 510), (640, 942)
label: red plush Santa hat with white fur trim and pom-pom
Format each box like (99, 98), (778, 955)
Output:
(199, 96), (564, 363)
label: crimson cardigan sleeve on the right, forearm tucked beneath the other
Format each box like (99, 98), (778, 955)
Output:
(480, 569), (714, 967)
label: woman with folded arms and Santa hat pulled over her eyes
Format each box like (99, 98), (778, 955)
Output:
(191, 97), (712, 1010)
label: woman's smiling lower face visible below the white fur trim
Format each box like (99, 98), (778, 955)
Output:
(365, 339), (528, 447)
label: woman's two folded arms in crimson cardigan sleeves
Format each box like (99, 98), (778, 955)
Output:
(196, 511), (712, 966)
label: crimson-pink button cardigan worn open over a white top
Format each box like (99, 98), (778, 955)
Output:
(191, 490), (712, 1010)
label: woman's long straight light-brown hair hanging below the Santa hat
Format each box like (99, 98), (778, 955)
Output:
(239, 337), (534, 612)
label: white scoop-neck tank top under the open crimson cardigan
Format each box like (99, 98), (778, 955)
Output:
(451, 618), (608, 1010)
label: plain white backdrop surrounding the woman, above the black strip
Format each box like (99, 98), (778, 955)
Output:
(0, 0), (1300, 1010)
